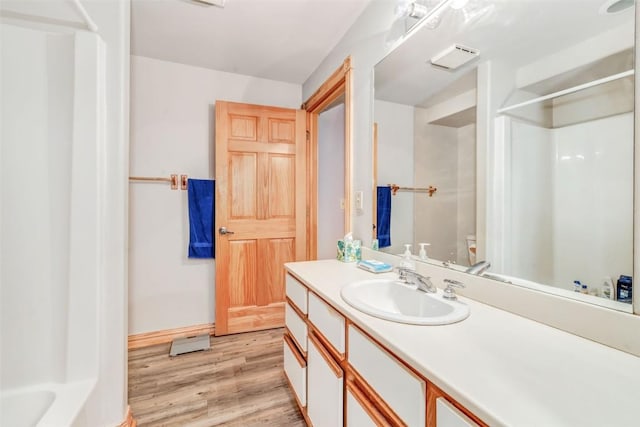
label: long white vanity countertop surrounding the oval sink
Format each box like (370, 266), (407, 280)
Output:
(286, 260), (640, 427)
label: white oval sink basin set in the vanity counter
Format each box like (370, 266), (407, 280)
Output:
(340, 279), (469, 325)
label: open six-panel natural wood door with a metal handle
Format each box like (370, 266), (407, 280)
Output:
(215, 101), (307, 335)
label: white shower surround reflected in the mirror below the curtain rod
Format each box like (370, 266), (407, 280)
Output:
(508, 113), (633, 290)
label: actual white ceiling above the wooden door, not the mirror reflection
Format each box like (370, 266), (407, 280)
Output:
(131, 0), (370, 84)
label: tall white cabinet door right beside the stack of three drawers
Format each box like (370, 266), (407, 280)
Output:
(307, 333), (344, 427)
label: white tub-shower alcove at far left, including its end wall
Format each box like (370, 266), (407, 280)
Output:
(0, 1), (129, 426)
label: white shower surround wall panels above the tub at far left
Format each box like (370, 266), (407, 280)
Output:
(0, 24), (74, 389)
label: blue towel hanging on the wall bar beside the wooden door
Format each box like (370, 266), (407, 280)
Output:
(187, 179), (216, 258)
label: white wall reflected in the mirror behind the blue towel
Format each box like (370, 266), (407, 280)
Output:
(376, 100), (419, 254)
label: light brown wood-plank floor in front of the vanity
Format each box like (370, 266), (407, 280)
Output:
(129, 329), (306, 427)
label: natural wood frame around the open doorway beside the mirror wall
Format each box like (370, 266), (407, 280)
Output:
(301, 56), (353, 260)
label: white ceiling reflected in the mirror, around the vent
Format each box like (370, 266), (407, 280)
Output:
(375, 0), (634, 107)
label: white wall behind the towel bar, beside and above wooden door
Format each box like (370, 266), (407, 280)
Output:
(129, 56), (302, 334)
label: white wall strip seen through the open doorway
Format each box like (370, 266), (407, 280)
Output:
(318, 104), (347, 259)
